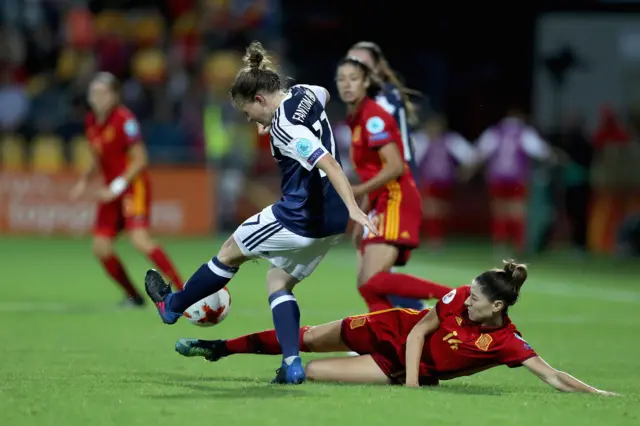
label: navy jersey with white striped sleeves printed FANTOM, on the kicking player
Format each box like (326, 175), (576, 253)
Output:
(271, 86), (349, 238)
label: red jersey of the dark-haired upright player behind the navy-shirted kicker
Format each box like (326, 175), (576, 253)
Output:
(347, 97), (415, 206)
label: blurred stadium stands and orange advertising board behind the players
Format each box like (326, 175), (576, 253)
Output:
(0, 0), (640, 254)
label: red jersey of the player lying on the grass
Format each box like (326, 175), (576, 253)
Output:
(420, 286), (537, 379)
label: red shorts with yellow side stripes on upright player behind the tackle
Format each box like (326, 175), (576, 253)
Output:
(360, 183), (422, 266)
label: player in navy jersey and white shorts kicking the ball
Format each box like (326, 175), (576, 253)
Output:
(145, 42), (378, 384)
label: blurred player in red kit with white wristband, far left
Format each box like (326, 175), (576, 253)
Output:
(71, 73), (182, 306)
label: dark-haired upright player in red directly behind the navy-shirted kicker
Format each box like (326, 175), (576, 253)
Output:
(336, 57), (449, 311)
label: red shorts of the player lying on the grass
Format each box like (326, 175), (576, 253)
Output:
(340, 308), (429, 383)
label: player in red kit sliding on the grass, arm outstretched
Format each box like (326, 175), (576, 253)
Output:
(176, 262), (616, 395)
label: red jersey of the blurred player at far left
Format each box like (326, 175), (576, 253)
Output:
(85, 105), (145, 184)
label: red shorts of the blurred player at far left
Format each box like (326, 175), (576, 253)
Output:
(93, 179), (151, 238)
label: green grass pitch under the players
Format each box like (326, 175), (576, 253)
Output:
(0, 237), (640, 426)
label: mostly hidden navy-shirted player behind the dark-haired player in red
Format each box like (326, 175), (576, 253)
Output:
(347, 41), (422, 310)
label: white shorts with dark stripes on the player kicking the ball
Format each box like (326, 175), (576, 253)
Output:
(233, 206), (342, 281)
